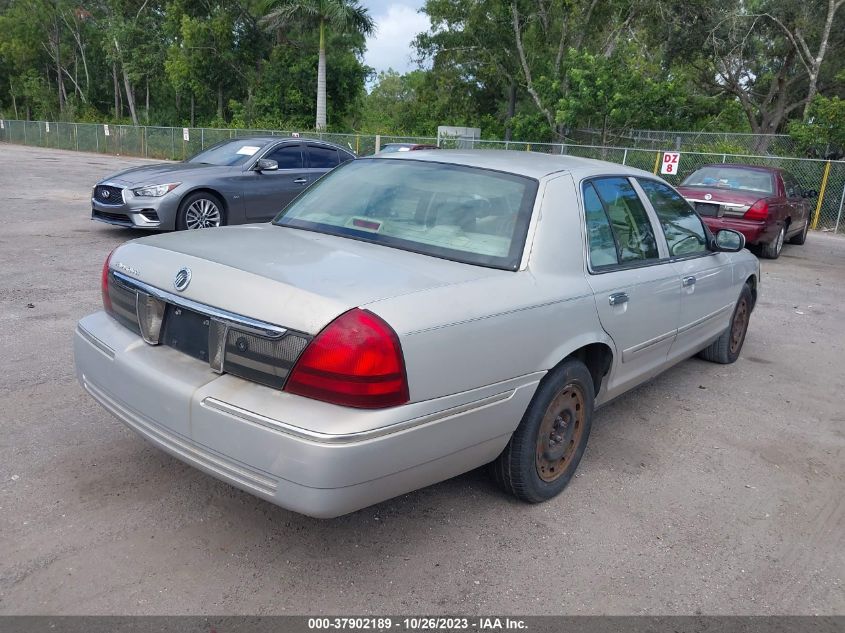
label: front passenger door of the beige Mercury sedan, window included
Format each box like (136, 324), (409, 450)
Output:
(637, 178), (737, 360)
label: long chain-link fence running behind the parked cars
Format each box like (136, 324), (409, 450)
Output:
(0, 120), (845, 233)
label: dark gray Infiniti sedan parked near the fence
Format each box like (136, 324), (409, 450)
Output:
(91, 137), (354, 230)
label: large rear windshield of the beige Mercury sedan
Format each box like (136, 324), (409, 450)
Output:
(275, 159), (537, 270)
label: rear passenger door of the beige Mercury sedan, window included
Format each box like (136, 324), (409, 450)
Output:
(581, 176), (680, 397)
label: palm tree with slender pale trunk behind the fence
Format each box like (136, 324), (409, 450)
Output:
(262, 0), (376, 130)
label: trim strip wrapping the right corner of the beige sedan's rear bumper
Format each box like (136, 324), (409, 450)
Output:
(201, 389), (516, 444)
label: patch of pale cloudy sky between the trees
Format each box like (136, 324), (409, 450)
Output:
(362, 0), (429, 73)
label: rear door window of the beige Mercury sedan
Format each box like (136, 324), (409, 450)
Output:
(592, 178), (660, 264)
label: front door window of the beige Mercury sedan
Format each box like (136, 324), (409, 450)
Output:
(637, 178), (707, 257)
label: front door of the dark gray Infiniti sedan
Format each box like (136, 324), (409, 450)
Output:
(244, 143), (308, 221)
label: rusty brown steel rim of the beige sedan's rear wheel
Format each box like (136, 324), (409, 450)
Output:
(535, 383), (586, 482)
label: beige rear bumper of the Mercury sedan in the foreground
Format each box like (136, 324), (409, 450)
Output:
(74, 312), (541, 518)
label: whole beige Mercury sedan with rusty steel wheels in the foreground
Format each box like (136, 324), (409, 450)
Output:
(75, 150), (760, 517)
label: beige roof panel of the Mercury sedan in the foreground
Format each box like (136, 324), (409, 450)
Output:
(368, 149), (654, 179)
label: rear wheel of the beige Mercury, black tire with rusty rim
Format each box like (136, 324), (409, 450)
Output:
(491, 359), (595, 503)
